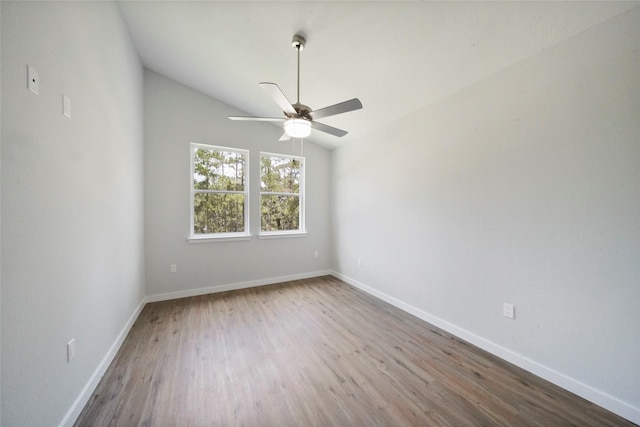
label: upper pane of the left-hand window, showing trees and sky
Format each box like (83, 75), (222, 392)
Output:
(193, 148), (245, 191)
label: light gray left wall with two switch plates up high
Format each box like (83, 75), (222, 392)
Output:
(0, 1), (144, 426)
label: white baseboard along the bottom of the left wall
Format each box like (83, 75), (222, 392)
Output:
(60, 299), (146, 427)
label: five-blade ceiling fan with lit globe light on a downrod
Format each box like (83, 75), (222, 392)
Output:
(229, 34), (362, 141)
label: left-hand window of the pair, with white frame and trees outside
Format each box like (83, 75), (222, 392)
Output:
(191, 144), (249, 239)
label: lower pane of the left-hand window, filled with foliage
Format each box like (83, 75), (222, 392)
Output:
(193, 193), (244, 234)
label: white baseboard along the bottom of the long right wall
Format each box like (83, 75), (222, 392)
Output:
(331, 272), (640, 424)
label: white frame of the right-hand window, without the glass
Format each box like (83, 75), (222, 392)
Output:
(258, 151), (307, 239)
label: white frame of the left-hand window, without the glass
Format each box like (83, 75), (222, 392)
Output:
(188, 142), (251, 243)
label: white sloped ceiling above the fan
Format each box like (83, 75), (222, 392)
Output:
(119, 1), (638, 148)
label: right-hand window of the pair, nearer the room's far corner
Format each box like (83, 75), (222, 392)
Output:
(260, 153), (304, 234)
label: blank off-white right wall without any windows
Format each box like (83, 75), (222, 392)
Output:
(332, 8), (640, 423)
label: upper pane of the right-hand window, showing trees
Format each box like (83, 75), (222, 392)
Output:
(260, 157), (300, 193)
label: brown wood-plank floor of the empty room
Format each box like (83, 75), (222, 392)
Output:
(75, 276), (634, 427)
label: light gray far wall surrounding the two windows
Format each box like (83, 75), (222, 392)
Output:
(144, 70), (330, 296)
